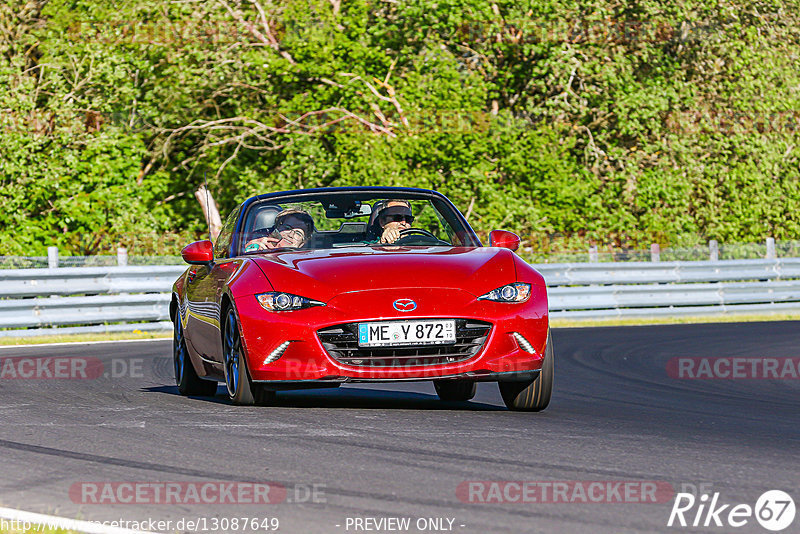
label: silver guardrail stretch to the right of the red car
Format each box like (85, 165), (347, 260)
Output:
(536, 258), (800, 319)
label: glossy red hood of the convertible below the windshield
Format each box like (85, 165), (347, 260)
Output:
(253, 247), (516, 302)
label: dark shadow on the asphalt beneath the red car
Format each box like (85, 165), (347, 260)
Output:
(137, 386), (506, 411)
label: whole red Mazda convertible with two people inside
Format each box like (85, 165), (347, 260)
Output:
(170, 187), (553, 411)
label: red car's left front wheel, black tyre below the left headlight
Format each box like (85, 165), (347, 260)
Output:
(222, 306), (276, 406)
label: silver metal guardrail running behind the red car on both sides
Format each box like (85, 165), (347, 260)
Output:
(0, 258), (800, 336)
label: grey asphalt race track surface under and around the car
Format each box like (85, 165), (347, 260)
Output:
(0, 322), (800, 534)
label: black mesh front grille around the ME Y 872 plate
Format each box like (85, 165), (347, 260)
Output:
(317, 319), (492, 367)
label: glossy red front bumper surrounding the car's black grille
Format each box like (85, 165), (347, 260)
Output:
(236, 286), (548, 386)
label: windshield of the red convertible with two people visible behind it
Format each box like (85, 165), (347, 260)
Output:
(238, 192), (480, 254)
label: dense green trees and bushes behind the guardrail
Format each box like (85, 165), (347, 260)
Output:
(0, 0), (800, 255)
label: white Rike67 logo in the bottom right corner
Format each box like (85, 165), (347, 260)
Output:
(667, 490), (796, 532)
